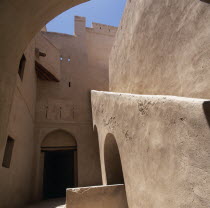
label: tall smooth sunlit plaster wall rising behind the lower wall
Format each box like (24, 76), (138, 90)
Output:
(110, 0), (210, 98)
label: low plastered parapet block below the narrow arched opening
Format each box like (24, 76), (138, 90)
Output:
(66, 185), (128, 208)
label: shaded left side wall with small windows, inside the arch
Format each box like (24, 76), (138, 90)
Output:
(0, 40), (36, 208)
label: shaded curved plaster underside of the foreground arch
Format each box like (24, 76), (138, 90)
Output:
(0, 0), (85, 186)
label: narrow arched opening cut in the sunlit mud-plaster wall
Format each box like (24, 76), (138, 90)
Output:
(104, 134), (124, 185)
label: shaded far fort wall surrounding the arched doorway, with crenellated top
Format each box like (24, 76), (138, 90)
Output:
(34, 17), (117, 199)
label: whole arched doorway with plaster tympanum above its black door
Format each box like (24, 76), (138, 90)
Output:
(41, 130), (77, 199)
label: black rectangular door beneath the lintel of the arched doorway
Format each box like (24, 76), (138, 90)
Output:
(43, 150), (76, 199)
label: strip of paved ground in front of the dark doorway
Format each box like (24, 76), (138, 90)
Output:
(25, 198), (66, 208)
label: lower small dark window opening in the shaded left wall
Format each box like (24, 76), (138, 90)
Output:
(2, 136), (15, 168)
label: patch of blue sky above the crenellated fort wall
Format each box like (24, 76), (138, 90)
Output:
(47, 0), (126, 34)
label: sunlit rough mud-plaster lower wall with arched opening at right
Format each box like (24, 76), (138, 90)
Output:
(92, 91), (210, 208)
